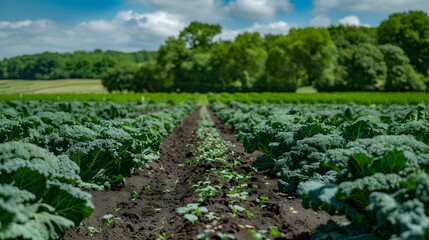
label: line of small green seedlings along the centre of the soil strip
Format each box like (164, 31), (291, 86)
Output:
(176, 106), (282, 239)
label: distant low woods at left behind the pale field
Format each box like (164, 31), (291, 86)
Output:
(0, 49), (156, 80)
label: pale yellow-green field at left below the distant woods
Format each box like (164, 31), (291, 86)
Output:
(0, 79), (107, 94)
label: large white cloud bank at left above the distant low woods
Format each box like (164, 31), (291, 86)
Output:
(0, 11), (187, 59)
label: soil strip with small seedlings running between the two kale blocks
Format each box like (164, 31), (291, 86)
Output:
(65, 106), (343, 239)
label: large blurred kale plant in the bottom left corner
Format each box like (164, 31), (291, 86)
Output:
(0, 142), (94, 239)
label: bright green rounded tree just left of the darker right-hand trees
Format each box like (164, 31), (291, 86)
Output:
(267, 28), (337, 90)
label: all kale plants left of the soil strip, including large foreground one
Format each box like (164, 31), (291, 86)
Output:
(0, 101), (193, 239)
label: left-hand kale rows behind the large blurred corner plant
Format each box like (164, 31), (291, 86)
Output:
(0, 98), (193, 187)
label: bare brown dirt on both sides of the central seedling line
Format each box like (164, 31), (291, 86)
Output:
(64, 108), (344, 240)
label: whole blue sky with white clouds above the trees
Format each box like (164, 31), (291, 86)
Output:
(0, 0), (429, 59)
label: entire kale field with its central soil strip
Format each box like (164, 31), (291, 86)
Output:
(0, 96), (429, 240)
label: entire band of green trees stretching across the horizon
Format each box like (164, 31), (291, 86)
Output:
(0, 11), (429, 92)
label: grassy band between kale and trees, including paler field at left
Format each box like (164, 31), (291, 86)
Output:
(0, 79), (429, 104)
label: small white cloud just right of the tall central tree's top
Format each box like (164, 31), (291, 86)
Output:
(218, 21), (292, 40)
